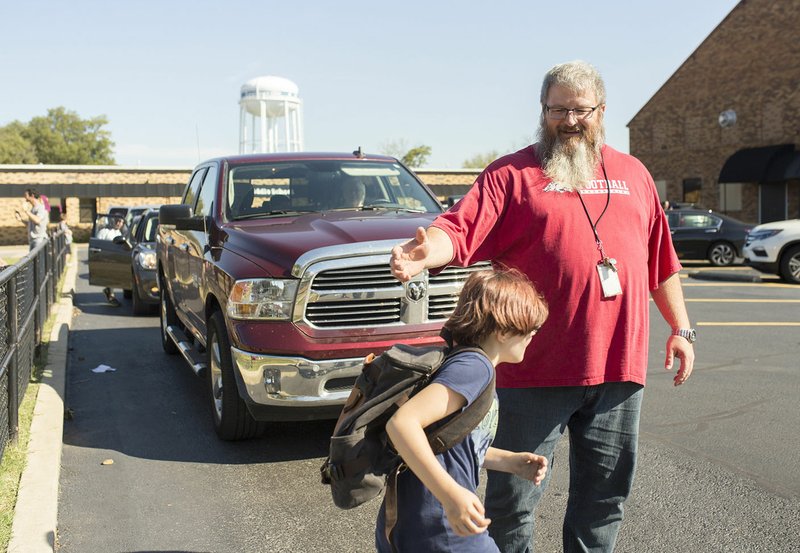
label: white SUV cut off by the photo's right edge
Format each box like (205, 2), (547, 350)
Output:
(744, 219), (800, 284)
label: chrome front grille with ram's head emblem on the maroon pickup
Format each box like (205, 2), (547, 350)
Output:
(304, 263), (489, 329)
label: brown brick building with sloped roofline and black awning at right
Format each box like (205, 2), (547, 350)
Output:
(628, 0), (800, 223)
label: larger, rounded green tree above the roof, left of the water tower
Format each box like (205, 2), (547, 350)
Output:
(23, 107), (114, 165)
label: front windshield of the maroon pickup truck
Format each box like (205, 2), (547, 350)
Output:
(226, 160), (442, 219)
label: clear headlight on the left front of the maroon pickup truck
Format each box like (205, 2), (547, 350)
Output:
(227, 278), (298, 321)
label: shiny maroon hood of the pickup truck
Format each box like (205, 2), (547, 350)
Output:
(222, 211), (437, 276)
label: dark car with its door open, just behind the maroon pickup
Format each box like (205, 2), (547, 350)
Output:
(89, 209), (160, 315)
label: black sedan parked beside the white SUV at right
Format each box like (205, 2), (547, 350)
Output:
(666, 209), (752, 267)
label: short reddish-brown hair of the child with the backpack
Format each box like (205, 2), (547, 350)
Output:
(444, 268), (548, 346)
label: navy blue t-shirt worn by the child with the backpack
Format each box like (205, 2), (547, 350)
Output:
(375, 351), (498, 553)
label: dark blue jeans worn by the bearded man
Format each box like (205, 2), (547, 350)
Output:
(486, 382), (643, 553)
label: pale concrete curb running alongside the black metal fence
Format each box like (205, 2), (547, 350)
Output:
(8, 248), (78, 553)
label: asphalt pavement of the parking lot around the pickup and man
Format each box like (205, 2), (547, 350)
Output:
(45, 252), (800, 552)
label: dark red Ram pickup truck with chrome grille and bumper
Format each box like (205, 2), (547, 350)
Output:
(157, 150), (477, 440)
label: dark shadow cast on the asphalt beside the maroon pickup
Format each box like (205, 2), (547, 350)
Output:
(64, 324), (335, 464)
